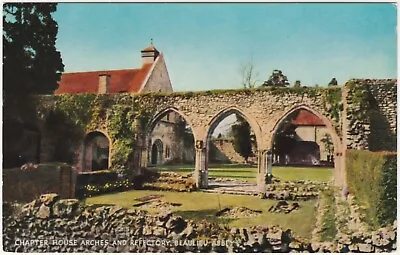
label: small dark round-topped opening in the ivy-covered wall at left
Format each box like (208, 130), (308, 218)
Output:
(83, 131), (110, 171)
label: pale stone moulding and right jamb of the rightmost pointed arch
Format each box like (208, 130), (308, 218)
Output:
(263, 105), (345, 186)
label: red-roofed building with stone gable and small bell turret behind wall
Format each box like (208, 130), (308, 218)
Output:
(55, 44), (173, 94)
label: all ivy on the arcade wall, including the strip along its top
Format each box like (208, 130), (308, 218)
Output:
(33, 87), (343, 173)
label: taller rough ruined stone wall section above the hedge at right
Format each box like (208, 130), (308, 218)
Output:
(344, 79), (397, 151)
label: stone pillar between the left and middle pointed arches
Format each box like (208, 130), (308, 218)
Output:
(194, 140), (208, 188)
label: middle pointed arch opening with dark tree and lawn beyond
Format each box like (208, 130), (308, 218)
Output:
(206, 107), (260, 192)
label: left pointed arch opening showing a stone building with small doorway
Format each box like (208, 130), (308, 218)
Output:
(146, 108), (195, 173)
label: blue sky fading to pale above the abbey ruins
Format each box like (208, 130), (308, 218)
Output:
(54, 3), (397, 91)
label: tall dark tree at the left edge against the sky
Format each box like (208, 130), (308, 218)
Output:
(3, 3), (64, 167)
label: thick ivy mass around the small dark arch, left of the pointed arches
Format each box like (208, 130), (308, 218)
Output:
(38, 94), (157, 175)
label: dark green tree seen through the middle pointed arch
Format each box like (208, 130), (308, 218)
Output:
(232, 114), (253, 162)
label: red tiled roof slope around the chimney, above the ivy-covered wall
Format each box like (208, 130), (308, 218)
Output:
(55, 64), (152, 94)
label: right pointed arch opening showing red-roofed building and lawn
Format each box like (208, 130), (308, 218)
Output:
(270, 106), (338, 181)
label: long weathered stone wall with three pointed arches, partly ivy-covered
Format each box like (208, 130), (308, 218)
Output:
(16, 80), (397, 191)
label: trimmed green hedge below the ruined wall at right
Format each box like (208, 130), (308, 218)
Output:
(346, 150), (397, 228)
